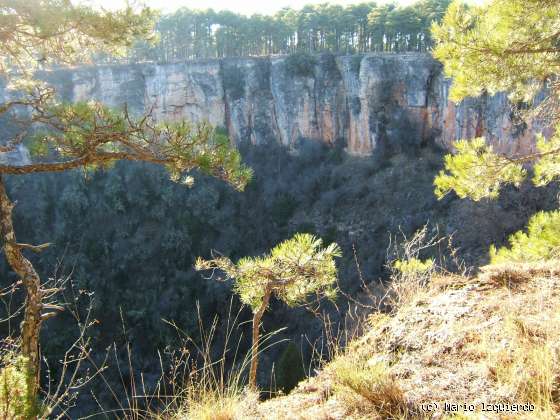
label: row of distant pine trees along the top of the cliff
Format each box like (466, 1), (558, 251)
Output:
(131, 0), (450, 61)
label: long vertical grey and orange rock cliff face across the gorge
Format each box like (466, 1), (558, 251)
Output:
(32, 53), (539, 155)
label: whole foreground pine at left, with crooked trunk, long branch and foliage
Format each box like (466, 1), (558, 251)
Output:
(0, 0), (251, 418)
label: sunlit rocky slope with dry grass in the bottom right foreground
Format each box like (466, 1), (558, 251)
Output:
(248, 262), (560, 420)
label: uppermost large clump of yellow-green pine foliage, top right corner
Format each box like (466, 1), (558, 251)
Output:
(432, 0), (560, 105)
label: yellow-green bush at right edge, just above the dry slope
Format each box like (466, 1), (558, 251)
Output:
(490, 210), (560, 263)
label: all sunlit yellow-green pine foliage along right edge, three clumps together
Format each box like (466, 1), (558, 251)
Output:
(432, 0), (560, 261)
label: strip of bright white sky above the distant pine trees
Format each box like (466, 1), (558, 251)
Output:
(79, 0), (484, 15)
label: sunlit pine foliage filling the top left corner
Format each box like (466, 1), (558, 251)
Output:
(0, 0), (156, 77)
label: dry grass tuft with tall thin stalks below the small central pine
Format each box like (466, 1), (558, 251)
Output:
(96, 302), (277, 420)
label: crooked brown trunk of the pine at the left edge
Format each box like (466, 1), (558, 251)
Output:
(0, 176), (42, 406)
